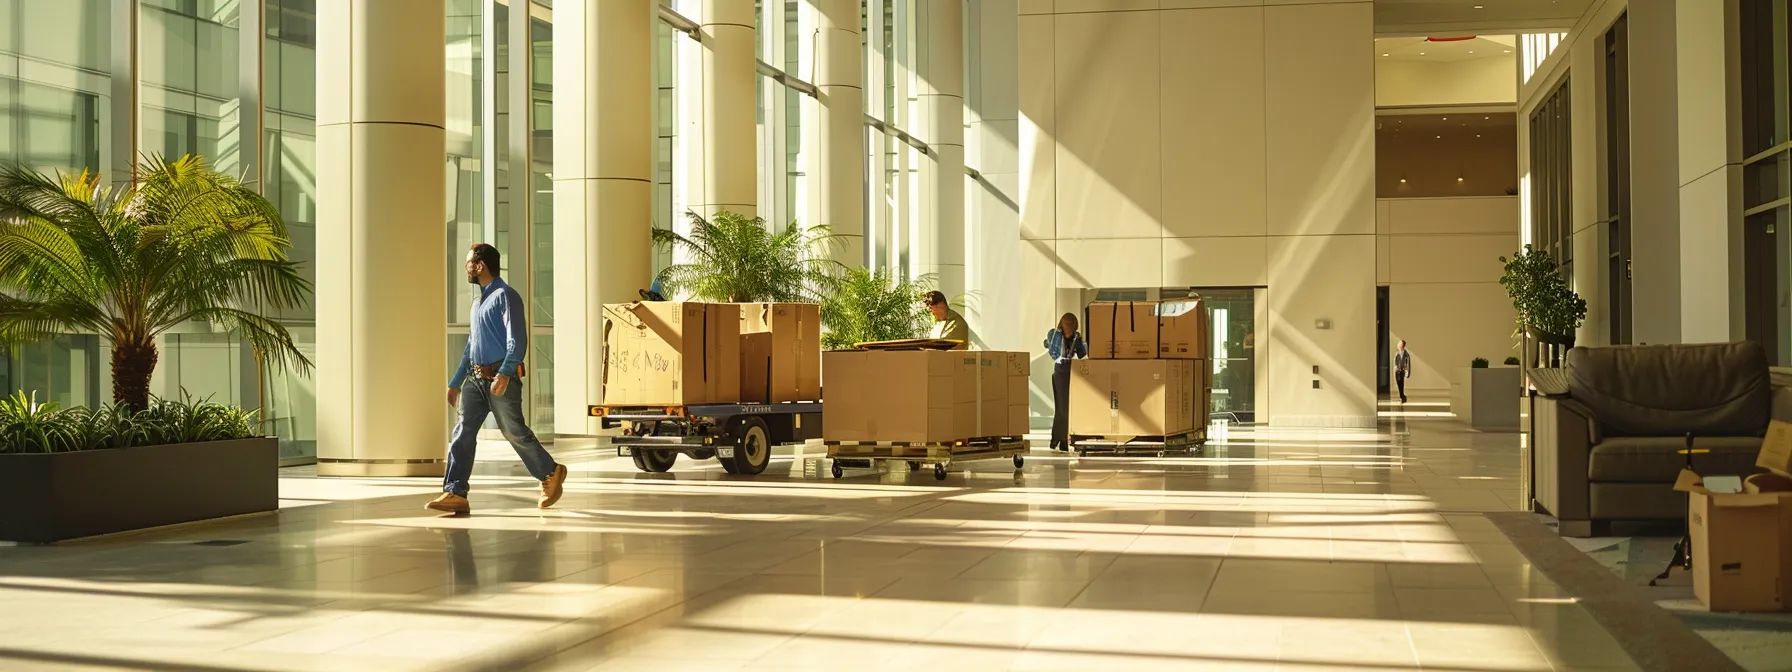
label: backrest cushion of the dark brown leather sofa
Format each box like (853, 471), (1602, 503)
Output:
(1566, 342), (1772, 437)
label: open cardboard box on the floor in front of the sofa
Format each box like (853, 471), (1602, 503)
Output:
(1674, 470), (1792, 611)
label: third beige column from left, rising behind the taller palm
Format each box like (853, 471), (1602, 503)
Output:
(692, 0), (760, 217)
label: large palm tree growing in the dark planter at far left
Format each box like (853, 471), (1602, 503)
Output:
(0, 156), (310, 410)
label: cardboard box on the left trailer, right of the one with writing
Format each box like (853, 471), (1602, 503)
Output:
(738, 303), (821, 403)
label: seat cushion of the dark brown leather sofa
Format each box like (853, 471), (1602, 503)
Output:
(1586, 437), (1762, 487)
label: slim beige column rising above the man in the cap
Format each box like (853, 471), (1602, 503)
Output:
(914, 0), (966, 304)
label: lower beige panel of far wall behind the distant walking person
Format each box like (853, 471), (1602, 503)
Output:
(1387, 283), (1518, 396)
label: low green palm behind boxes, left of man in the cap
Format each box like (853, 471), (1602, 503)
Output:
(821, 269), (934, 349)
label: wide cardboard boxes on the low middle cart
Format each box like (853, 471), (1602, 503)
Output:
(821, 349), (1029, 443)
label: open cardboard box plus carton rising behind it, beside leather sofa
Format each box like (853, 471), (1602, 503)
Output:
(1674, 419), (1792, 611)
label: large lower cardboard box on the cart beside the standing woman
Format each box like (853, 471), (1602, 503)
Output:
(1070, 360), (1199, 437)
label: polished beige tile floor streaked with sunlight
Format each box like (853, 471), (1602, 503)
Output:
(0, 407), (1634, 672)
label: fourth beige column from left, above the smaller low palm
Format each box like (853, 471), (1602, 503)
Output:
(803, 0), (866, 267)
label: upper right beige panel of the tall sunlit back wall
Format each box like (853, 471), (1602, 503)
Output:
(1263, 4), (1374, 238)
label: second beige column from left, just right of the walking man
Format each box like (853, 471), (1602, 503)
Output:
(554, 0), (659, 434)
